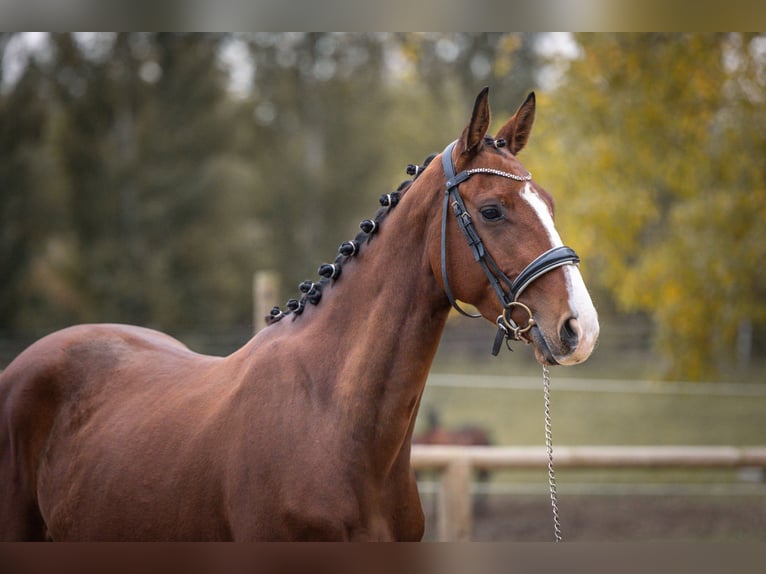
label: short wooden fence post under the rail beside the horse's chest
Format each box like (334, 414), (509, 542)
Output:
(437, 458), (473, 542)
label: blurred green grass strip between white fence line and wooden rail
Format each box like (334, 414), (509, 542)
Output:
(419, 375), (766, 446)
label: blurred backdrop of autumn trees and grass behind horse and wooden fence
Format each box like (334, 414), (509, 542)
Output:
(0, 33), (766, 540)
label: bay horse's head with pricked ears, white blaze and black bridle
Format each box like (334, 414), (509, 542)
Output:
(424, 88), (599, 365)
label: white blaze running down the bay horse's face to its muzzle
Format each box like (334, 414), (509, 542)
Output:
(521, 183), (599, 365)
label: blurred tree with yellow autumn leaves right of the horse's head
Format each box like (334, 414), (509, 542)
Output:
(531, 34), (766, 379)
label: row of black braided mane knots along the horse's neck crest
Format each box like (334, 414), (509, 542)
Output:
(264, 154), (437, 325)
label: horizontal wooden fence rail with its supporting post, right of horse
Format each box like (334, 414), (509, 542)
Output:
(411, 445), (766, 541)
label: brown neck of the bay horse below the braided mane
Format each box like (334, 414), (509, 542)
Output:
(255, 174), (449, 474)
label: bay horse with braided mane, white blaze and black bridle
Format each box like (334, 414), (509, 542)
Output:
(0, 88), (598, 541)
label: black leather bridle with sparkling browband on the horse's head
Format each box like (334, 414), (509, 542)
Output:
(441, 141), (580, 355)
